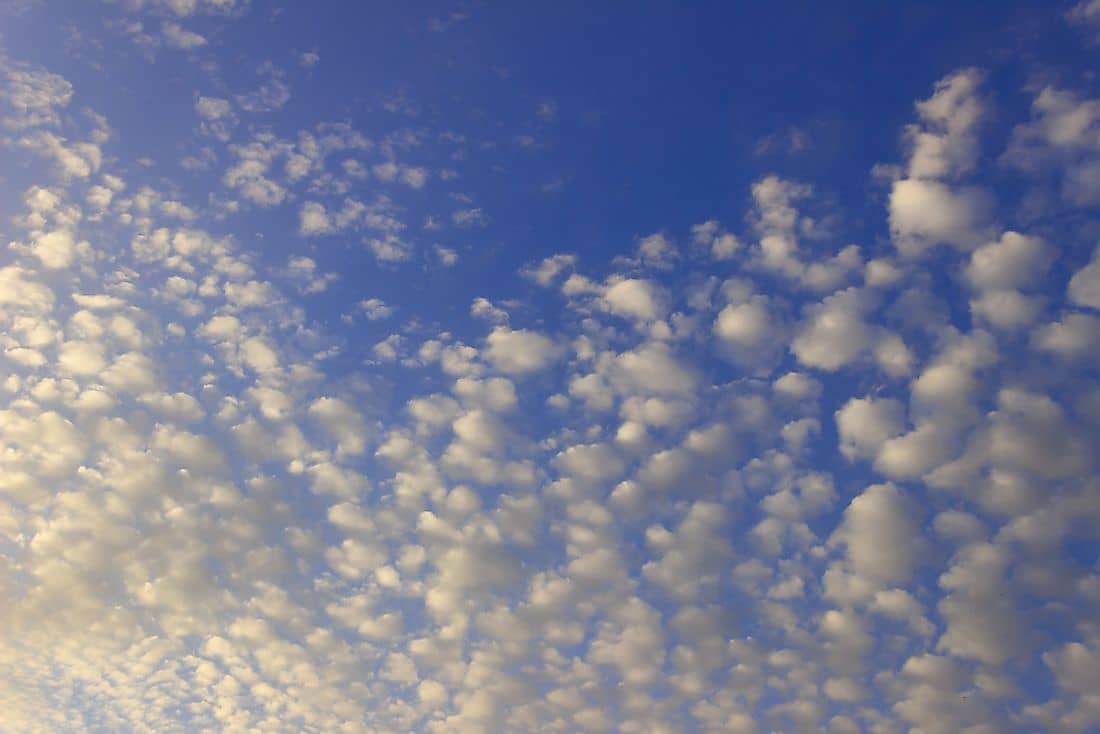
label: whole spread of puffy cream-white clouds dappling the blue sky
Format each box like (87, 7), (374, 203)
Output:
(0, 12), (1100, 734)
